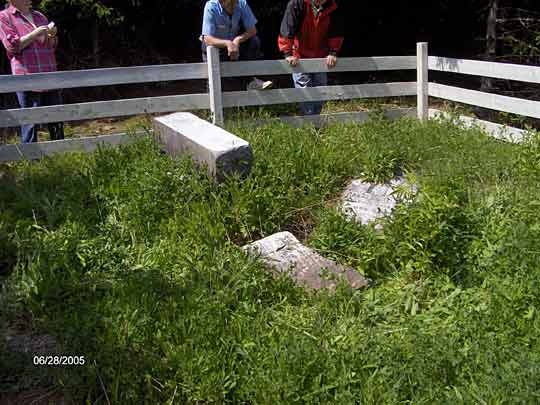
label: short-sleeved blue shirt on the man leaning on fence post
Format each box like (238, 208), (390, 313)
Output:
(202, 0), (257, 41)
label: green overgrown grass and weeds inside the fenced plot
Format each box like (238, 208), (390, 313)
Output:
(0, 116), (540, 404)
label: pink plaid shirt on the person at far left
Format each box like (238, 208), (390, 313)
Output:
(0, 5), (58, 75)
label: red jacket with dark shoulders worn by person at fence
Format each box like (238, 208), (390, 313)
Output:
(278, 0), (344, 58)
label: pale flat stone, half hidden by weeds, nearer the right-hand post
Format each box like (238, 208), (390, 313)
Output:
(341, 177), (416, 225)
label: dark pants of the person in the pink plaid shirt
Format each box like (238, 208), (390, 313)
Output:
(17, 90), (64, 143)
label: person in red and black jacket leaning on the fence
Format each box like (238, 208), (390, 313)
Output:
(278, 0), (344, 115)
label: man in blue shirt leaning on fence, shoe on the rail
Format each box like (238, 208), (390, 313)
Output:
(201, 0), (272, 90)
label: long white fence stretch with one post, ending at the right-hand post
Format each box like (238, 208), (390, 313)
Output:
(0, 43), (416, 127)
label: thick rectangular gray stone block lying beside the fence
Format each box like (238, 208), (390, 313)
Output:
(153, 112), (253, 181)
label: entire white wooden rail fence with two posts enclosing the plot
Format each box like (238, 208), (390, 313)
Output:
(0, 43), (540, 160)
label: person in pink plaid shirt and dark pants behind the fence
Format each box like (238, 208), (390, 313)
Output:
(0, 0), (64, 143)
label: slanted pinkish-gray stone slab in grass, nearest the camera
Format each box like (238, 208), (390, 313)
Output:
(242, 232), (369, 290)
